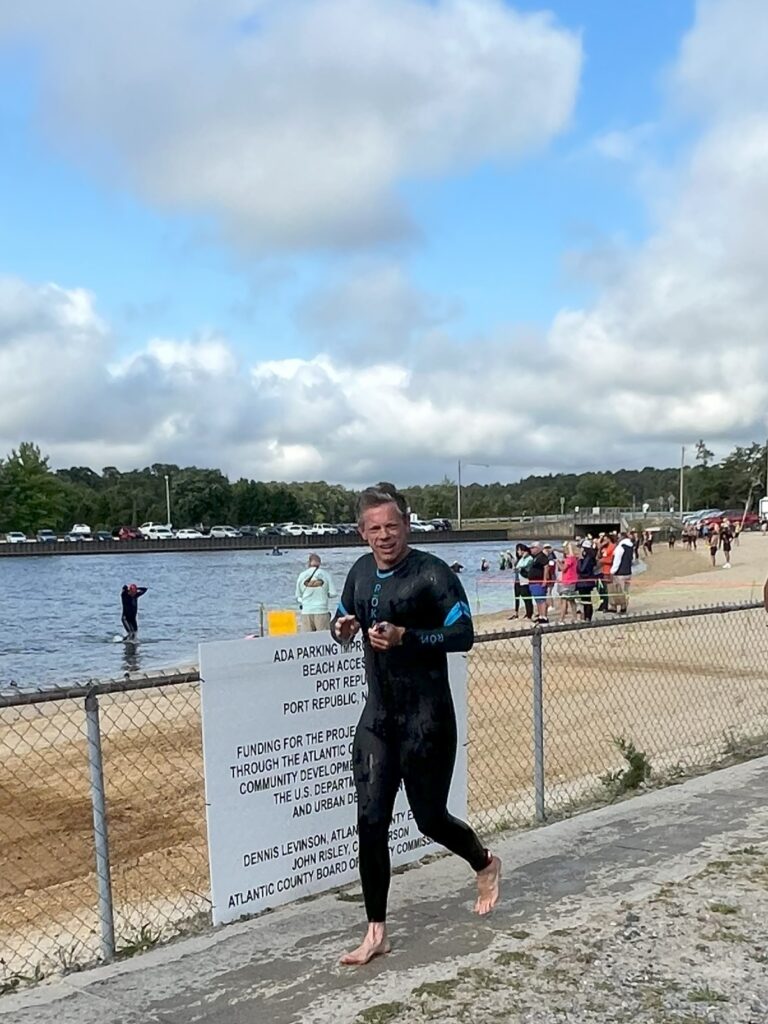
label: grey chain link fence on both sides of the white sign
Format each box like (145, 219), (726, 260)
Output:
(0, 604), (768, 992)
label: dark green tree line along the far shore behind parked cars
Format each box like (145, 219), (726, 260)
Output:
(0, 440), (766, 534)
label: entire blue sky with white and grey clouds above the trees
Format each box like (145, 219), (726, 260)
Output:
(0, 0), (768, 484)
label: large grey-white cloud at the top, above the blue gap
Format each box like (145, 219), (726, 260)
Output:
(0, 0), (581, 250)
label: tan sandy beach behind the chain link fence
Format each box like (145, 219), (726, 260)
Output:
(0, 535), (768, 972)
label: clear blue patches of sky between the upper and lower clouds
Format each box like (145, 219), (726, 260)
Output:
(0, 0), (693, 355)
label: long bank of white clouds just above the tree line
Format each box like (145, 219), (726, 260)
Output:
(0, 0), (768, 482)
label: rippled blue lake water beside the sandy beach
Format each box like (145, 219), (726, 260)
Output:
(0, 542), (528, 687)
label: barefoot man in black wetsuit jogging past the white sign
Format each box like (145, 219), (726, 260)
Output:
(331, 484), (501, 965)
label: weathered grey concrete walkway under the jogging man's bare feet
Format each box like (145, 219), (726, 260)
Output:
(0, 758), (768, 1024)
